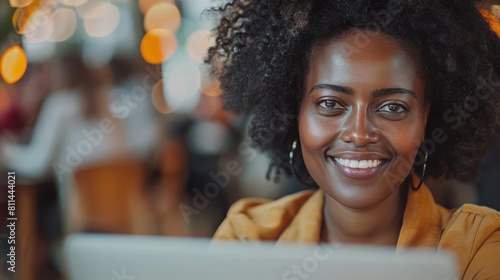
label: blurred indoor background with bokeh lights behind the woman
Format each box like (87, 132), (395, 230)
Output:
(0, 0), (500, 280)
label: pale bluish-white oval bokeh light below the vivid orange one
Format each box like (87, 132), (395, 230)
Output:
(164, 61), (201, 111)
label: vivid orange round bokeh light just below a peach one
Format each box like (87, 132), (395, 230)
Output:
(141, 29), (177, 64)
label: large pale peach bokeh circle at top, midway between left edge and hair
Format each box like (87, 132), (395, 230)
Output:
(83, 3), (120, 38)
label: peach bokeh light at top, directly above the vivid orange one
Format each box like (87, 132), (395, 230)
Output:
(144, 3), (181, 31)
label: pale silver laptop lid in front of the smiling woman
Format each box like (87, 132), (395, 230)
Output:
(64, 234), (457, 280)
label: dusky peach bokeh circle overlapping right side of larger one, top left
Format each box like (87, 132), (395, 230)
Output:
(50, 8), (77, 42)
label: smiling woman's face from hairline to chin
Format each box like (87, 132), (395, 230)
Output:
(298, 32), (428, 209)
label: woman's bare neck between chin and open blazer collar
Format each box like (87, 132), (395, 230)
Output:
(321, 184), (408, 246)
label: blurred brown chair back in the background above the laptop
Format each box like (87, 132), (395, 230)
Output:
(75, 159), (152, 234)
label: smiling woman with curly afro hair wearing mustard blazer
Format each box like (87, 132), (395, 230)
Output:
(207, 0), (500, 279)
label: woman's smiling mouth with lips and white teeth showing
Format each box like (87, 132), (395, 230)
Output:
(329, 157), (388, 179)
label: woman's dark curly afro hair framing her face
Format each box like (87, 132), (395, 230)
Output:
(206, 0), (500, 181)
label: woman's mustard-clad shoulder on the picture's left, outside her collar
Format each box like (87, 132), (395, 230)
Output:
(214, 190), (315, 240)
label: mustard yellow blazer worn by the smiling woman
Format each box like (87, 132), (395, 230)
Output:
(214, 182), (500, 280)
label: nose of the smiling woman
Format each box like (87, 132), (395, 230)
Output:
(340, 109), (380, 147)
